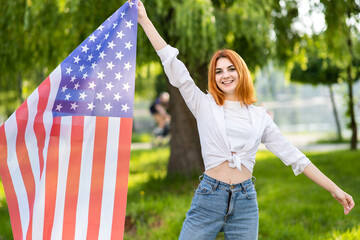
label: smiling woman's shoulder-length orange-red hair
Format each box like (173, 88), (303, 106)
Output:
(208, 49), (256, 105)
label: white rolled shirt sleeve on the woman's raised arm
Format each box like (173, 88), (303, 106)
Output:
(157, 45), (205, 117)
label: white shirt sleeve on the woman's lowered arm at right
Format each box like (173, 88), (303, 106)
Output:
(261, 113), (310, 175)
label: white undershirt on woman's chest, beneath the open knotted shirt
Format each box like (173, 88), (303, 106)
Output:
(224, 101), (252, 152)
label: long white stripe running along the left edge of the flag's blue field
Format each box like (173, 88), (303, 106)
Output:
(32, 65), (61, 240)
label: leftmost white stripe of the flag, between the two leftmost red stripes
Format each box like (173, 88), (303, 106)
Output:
(4, 113), (30, 239)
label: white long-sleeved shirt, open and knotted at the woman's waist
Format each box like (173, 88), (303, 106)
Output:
(157, 45), (310, 175)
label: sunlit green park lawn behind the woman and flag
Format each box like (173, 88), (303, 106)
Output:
(0, 148), (360, 240)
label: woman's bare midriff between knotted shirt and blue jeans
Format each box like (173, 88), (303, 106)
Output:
(205, 161), (252, 185)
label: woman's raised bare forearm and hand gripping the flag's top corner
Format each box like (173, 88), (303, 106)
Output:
(138, 0), (167, 51)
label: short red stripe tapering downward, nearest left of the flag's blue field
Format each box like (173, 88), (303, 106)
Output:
(34, 77), (51, 178)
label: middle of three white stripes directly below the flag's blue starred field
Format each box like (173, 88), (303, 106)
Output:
(75, 117), (96, 240)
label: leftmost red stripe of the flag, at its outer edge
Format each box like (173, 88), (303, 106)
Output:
(0, 125), (23, 240)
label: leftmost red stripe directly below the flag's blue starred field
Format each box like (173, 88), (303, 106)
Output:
(43, 117), (61, 240)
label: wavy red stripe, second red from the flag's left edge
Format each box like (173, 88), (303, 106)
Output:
(15, 100), (35, 239)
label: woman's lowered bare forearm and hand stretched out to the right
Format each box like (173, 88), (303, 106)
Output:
(303, 163), (355, 215)
